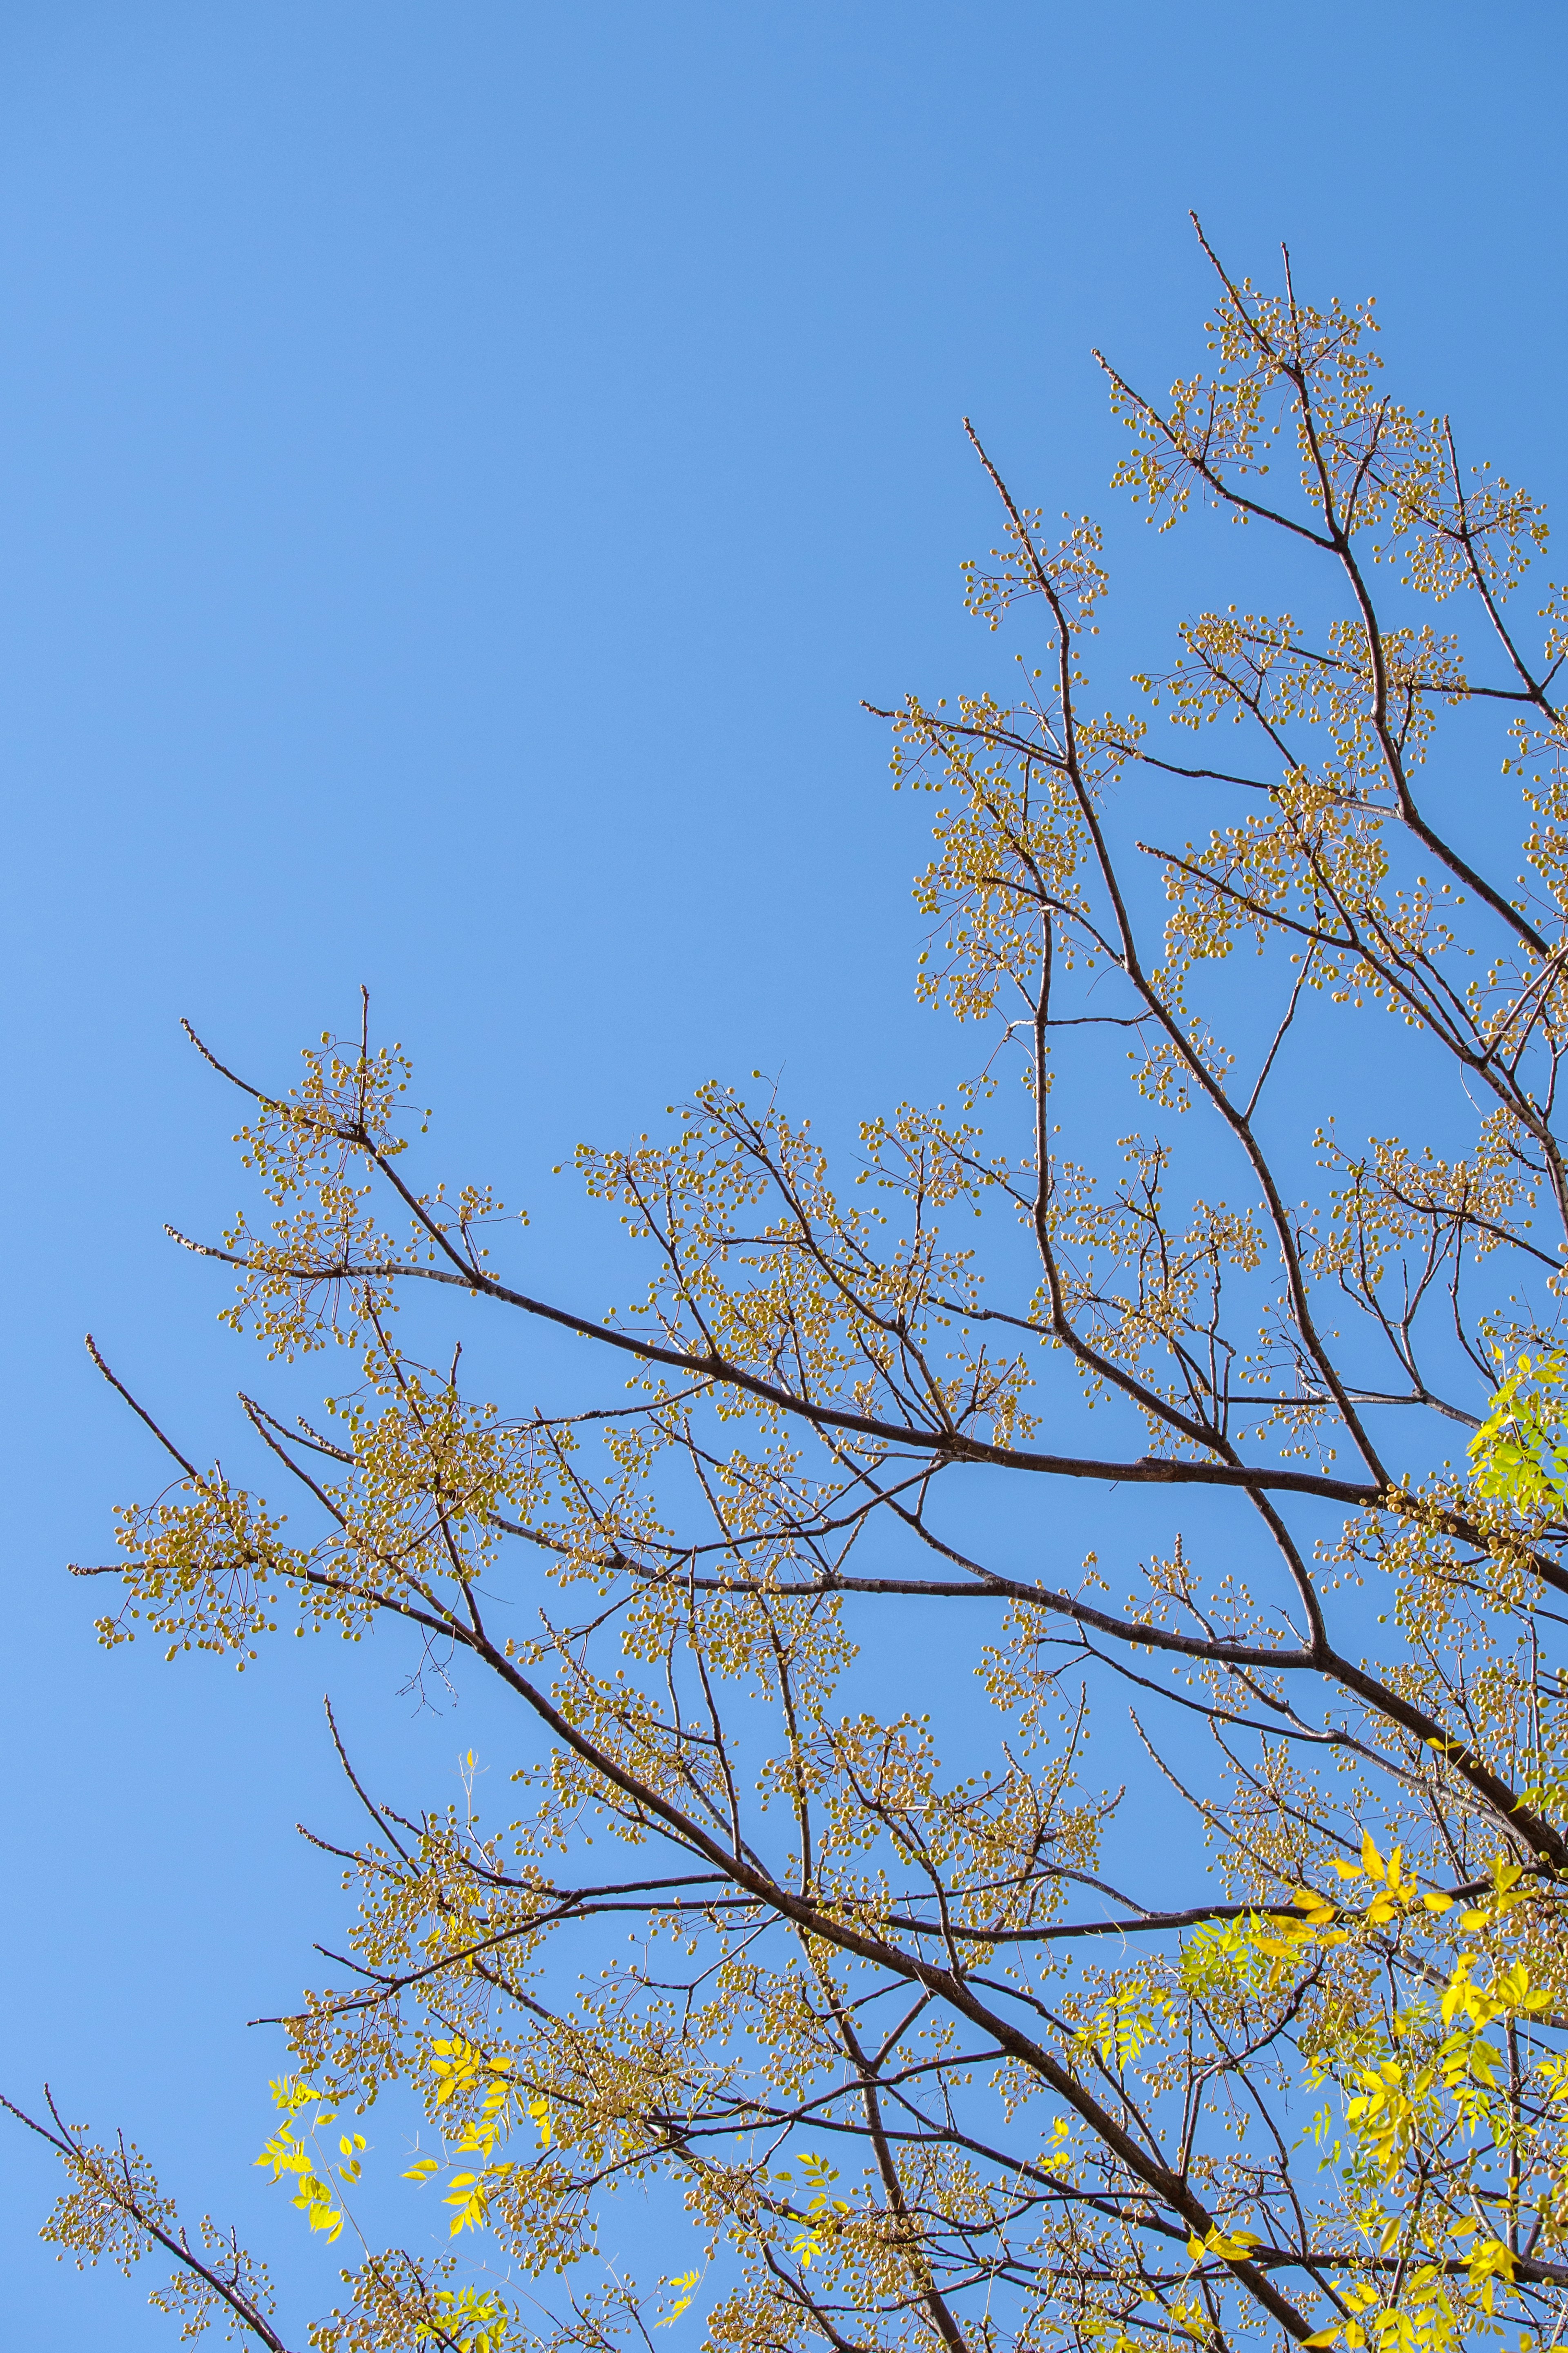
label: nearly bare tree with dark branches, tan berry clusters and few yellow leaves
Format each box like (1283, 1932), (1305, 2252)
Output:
(12, 229), (1568, 2353)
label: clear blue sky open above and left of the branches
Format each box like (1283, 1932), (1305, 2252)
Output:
(0, 0), (1568, 2353)
